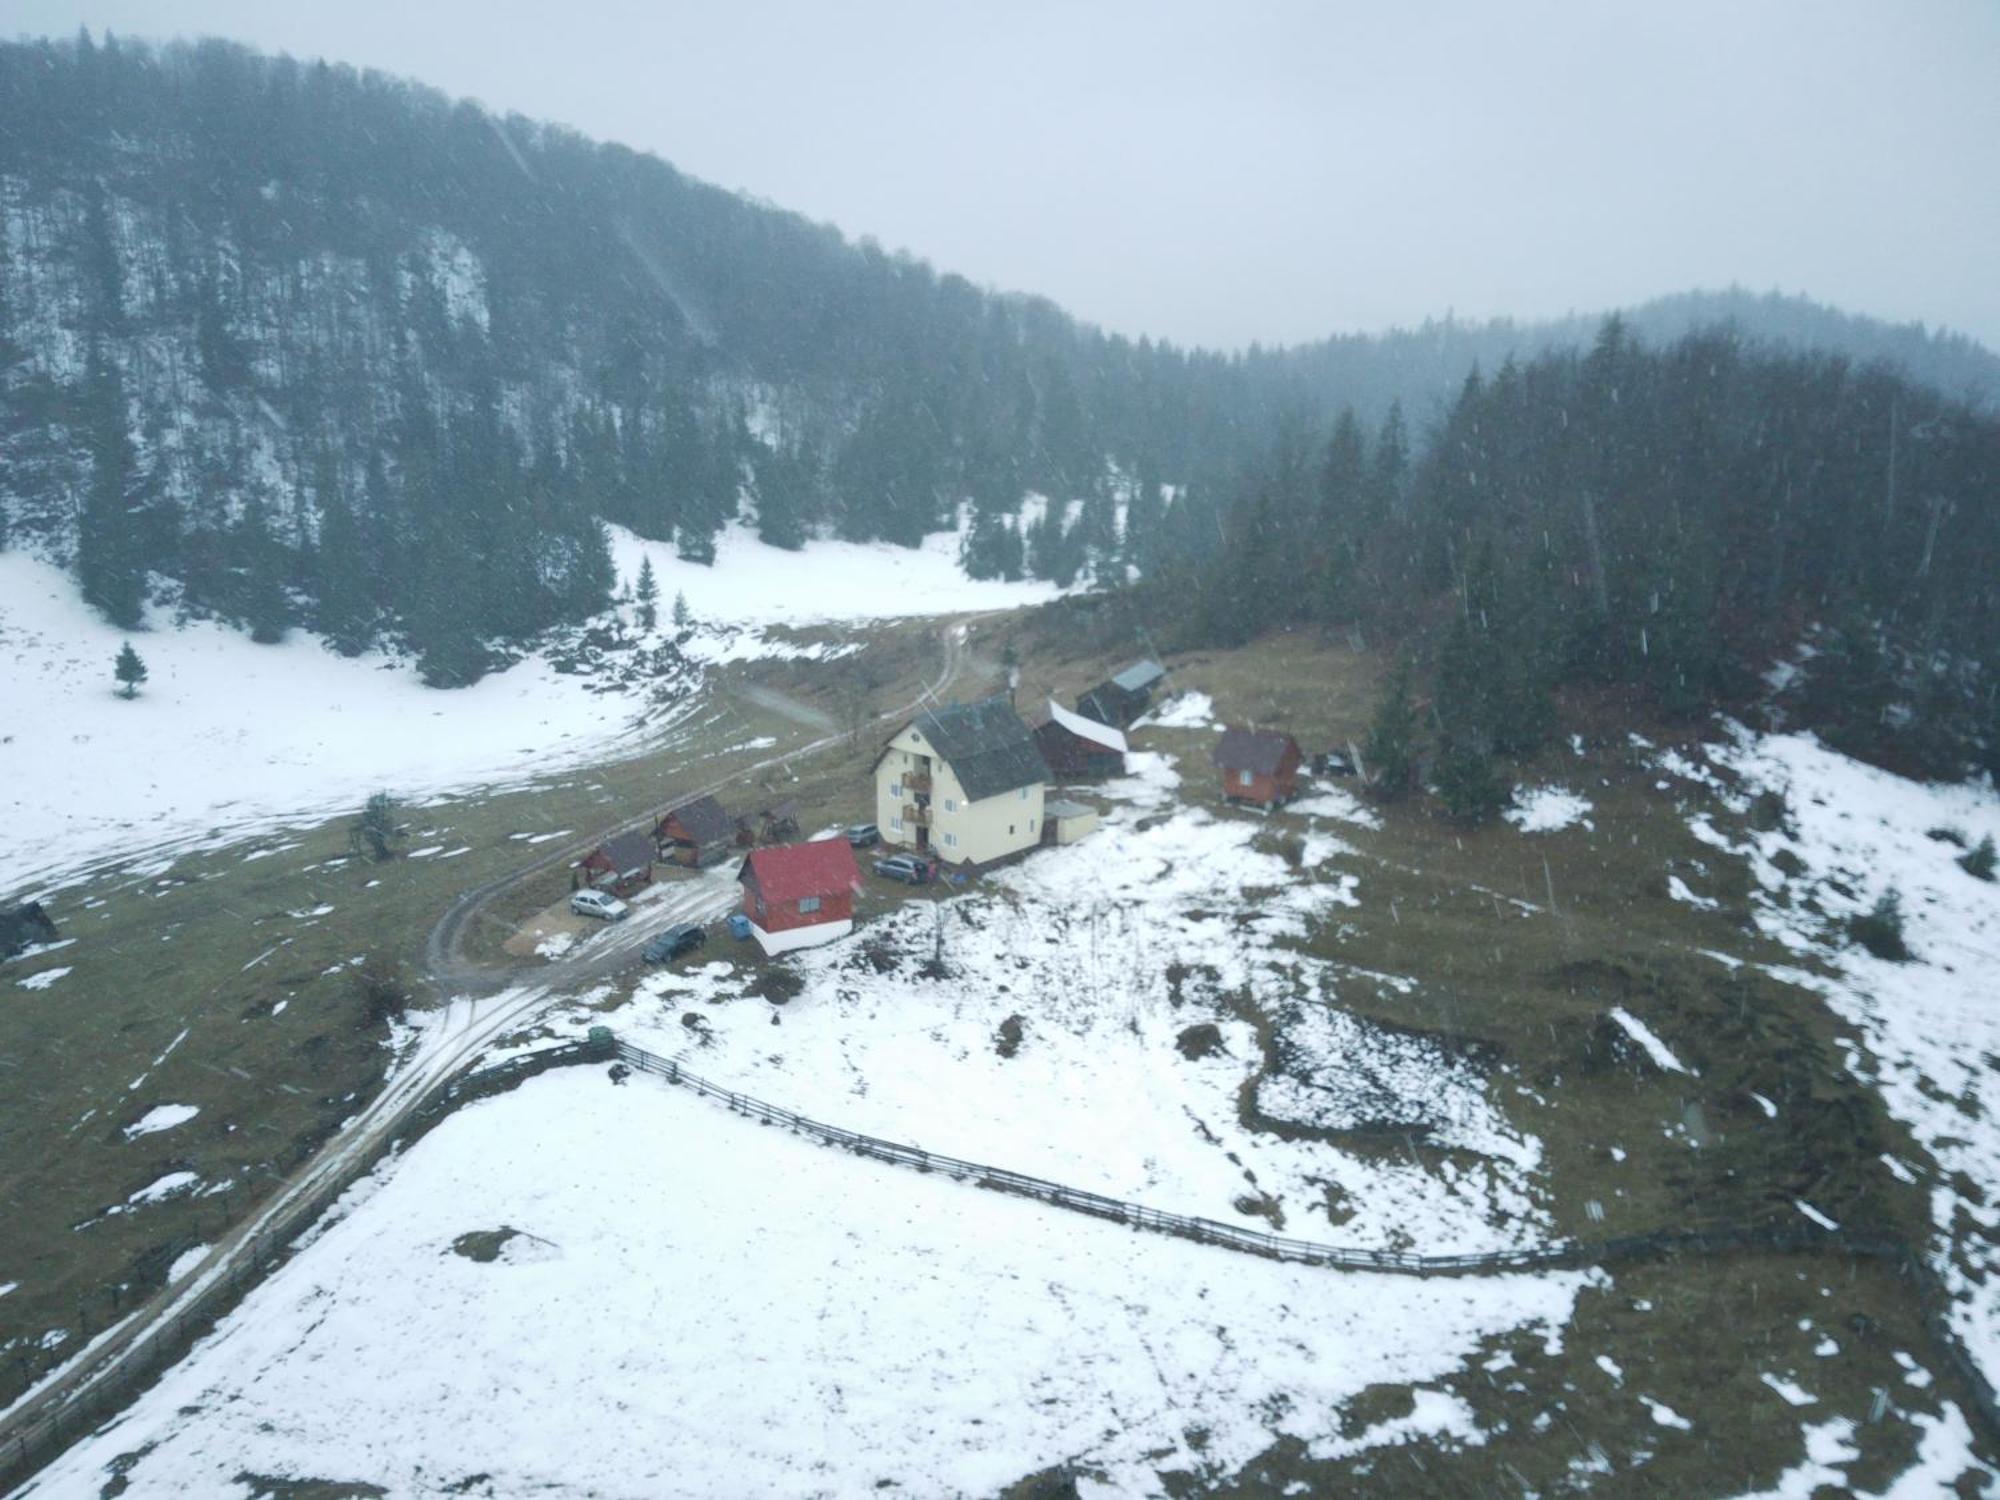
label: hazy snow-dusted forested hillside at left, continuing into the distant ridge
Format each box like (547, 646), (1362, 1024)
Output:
(0, 34), (2000, 684)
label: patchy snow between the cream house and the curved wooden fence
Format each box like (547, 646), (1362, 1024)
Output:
(532, 752), (1546, 1252)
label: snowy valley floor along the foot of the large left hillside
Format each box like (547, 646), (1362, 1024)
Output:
(0, 528), (1052, 894)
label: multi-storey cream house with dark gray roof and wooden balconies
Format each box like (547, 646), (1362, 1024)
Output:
(876, 698), (1048, 864)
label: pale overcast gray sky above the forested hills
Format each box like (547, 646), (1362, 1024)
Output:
(15, 0), (2000, 348)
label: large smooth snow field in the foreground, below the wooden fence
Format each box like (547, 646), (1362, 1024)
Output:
(32, 1068), (1582, 1500)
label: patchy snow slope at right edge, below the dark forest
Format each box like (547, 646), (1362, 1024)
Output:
(1696, 730), (2000, 1380)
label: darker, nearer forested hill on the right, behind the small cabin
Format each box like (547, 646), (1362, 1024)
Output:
(1142, 318), (2000, 816)
